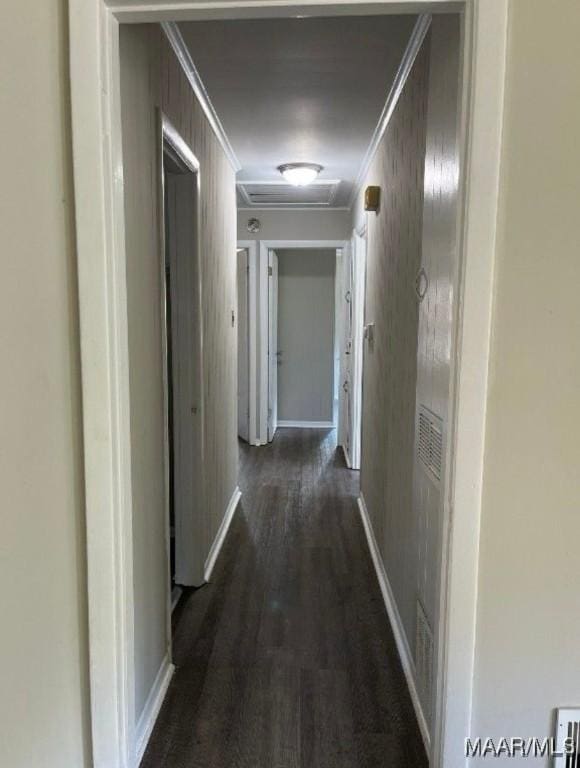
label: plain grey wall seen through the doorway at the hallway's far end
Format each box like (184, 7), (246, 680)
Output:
(276, 249), (336, 421)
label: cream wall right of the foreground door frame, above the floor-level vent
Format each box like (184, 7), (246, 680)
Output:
(472, 0), (580, 766)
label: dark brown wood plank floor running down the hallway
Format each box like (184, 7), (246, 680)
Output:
(141, 429), (427, 768)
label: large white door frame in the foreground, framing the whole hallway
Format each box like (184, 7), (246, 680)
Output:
(69, 0), (509, 768)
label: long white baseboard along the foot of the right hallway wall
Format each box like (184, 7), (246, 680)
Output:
(358, 493), (431, 754)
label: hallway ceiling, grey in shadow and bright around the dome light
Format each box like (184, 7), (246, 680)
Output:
(179, 15), (416, 207)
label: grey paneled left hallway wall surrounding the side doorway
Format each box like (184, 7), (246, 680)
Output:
(121, 25), (238, 718)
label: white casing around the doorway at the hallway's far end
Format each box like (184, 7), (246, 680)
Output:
(258, 240), (348, 444)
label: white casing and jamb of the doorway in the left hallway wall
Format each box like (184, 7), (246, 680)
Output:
(161, 116), (204, 586)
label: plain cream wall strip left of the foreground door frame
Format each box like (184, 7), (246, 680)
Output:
(0, 0), (90, 768)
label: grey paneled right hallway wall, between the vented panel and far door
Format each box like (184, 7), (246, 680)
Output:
(355, 33), (429, 648)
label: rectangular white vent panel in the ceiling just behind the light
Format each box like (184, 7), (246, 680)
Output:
(237, 179), (340, 208)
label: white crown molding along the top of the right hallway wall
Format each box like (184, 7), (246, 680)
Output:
(349, 13), (431, 208)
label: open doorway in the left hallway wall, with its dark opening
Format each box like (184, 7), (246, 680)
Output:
(161, 118), (203, 610)
